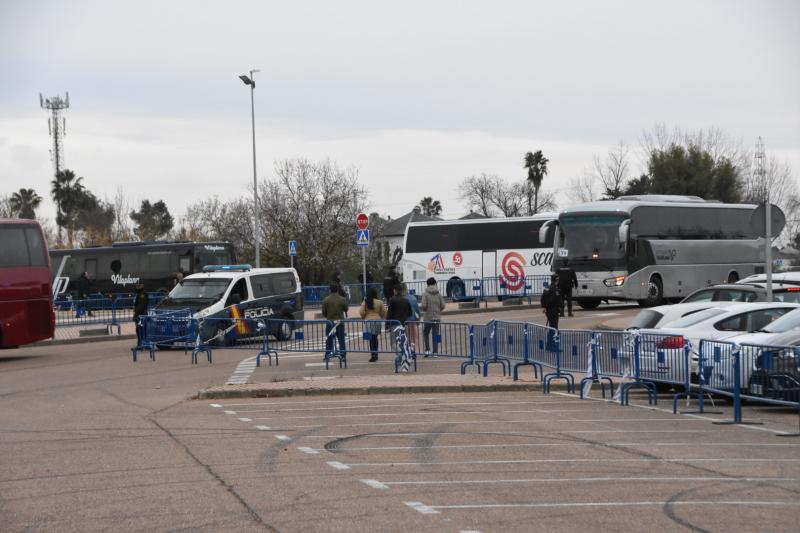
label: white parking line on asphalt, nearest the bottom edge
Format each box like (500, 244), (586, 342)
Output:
(404, 500), (800, 514)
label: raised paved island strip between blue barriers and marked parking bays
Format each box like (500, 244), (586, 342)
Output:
(197, 373), (544, 399)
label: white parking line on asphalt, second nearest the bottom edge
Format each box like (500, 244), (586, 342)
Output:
(360, 476), (800, 489)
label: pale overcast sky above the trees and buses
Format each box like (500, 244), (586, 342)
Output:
(0, 0), (800, 223)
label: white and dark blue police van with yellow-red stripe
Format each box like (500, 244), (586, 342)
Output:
(154, 265), (304, 340)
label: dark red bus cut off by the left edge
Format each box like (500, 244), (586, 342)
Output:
(0, 218), (55, 348)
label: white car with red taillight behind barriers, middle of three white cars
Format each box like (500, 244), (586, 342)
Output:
(639, 302), (800, 373)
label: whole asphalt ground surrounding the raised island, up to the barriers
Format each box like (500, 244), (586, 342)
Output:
(6, 309), (800, 532)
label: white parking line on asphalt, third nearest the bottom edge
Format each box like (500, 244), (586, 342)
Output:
(328, 457), (800, 470)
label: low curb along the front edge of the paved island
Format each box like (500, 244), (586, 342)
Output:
(193, 382), (566, 400)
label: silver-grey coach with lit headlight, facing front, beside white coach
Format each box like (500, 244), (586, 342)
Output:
(539, 195), (785, 309)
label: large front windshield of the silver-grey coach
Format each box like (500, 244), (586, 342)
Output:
(559, 215), (627, 261)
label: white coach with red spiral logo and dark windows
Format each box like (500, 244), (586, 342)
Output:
(401, 213), (556, 300)
